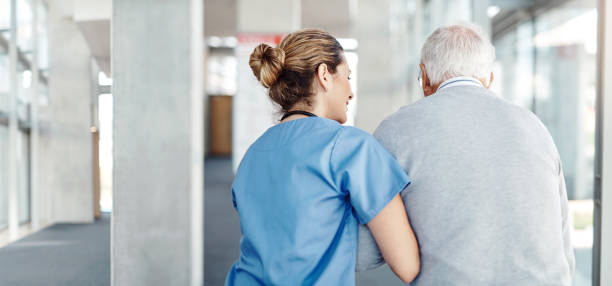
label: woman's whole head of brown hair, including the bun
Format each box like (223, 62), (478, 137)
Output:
(249, 29), (343, 112)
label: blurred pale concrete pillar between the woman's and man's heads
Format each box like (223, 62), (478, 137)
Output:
(355, 0), (417, 132)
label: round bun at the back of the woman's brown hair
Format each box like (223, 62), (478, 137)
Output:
(249, 44), (285, 88)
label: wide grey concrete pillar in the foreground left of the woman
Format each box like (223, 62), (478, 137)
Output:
(111, 0), (204, 285)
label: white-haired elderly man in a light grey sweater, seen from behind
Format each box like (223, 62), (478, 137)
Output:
(357, 24), (574, 286)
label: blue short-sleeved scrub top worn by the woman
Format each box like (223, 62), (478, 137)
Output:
(225, 117), (410, 286)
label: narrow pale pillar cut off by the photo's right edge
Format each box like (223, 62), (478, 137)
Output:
(593, 0), (612, 285)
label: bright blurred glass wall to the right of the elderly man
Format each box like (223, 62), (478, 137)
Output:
(494, 0), (597, 285)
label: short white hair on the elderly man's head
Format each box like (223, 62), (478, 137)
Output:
(421, 23), (495, 85)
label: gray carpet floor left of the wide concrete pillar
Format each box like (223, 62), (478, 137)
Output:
(0, 214), (110, 286)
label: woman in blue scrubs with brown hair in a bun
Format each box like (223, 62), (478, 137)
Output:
(225, 29), (420, 285)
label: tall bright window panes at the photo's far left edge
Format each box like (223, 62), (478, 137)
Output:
(0, 0), (48, 230)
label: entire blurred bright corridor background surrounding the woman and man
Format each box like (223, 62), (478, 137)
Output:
(0, 0), (612, 285)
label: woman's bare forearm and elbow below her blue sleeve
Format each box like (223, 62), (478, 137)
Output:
(368, 195), (421, 283)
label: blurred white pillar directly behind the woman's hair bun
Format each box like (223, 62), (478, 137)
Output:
(232, 0), (301, 170)
